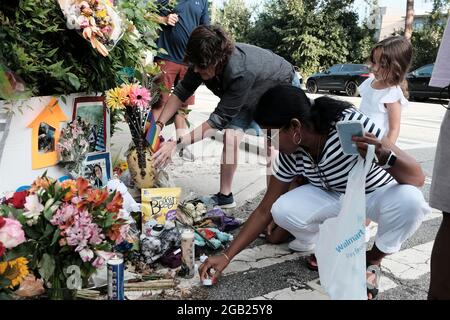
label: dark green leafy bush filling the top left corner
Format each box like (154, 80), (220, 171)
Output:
(0, 0), (159, 96)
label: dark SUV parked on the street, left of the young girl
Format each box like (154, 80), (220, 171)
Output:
(306, 64), (370, 97)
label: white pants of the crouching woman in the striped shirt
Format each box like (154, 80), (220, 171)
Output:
(272, 182), (431, 254)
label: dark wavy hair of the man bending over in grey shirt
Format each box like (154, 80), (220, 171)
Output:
(184, 25), (234, 70)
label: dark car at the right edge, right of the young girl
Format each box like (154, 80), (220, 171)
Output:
(406, 63), (450, 101)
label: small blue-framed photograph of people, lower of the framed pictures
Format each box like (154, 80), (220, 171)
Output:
(83, 152), (111, 188)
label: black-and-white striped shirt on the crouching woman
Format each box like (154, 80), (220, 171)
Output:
(272, 108), (393, 193)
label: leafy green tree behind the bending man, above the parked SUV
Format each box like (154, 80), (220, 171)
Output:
(244, 0), (373, 76)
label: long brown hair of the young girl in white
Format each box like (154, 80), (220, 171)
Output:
(370, 36), (413, 95)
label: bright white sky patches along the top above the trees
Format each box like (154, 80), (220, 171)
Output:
(215, 0), (433, 20)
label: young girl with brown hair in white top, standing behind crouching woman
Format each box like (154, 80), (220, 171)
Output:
(359, 36), (412, 143)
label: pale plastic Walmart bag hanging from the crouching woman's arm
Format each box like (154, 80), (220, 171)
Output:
(315, 145), (375, 300)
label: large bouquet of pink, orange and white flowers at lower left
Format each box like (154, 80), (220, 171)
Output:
(0, 174), (129, 298)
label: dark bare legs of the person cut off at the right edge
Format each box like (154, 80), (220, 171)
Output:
(428, 212), (450, 300)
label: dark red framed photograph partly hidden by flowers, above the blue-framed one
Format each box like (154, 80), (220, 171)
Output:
(72, 97), (108, 152)
